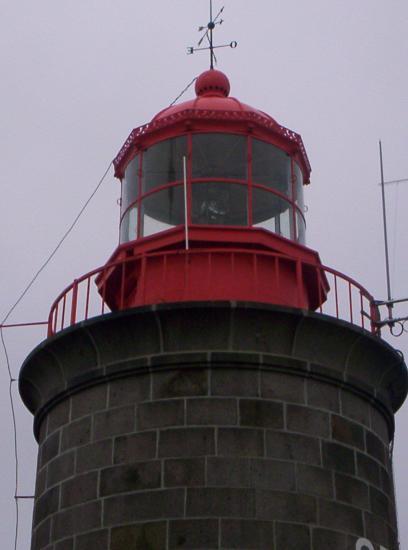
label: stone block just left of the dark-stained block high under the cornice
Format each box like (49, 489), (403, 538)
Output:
(108, 374), (151, 407)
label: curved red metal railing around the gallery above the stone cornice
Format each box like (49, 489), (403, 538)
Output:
(48, 248), (380, 336)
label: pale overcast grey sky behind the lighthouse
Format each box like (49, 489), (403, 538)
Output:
(0, 0), (408, 550)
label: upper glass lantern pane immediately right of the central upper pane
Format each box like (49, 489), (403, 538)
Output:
(252, 139), (292, 197)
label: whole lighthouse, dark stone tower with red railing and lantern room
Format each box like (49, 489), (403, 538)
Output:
(20, 70), (407, 550)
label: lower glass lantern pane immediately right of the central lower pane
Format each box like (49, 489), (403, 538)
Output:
(252, 187), (293, 239)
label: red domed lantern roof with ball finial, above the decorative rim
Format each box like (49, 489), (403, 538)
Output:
(152, 69), (273, 122)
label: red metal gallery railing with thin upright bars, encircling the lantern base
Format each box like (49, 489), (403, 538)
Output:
(48, 249), (380, 336)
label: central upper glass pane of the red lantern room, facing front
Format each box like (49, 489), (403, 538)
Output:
(193, 134), (248, 180)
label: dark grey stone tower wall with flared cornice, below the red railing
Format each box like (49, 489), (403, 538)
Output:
(20, 304), (407, 550)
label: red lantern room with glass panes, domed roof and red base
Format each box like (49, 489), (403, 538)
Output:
(97, 70), (328, 316)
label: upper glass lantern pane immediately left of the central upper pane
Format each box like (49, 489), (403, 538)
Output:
(142, 136), (187, 193)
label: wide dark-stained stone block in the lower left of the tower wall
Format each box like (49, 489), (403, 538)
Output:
(100, 460), (161, 497)
